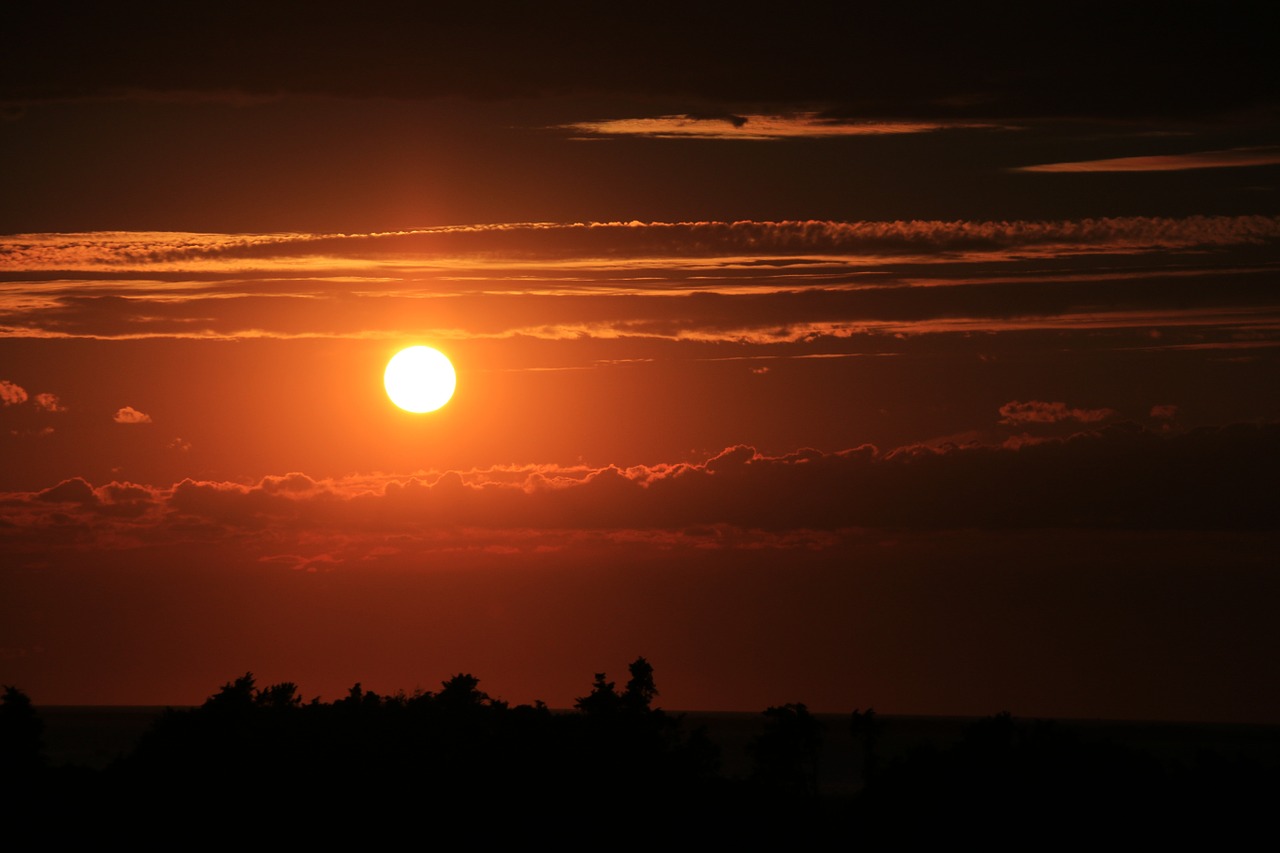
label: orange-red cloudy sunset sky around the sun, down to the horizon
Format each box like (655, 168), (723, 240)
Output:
(0, 3), (1280, 722)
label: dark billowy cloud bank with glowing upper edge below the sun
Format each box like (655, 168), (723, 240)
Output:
(4, 422), (1280, 558)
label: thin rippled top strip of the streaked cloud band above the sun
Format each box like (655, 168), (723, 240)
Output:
(10, 215), (1280, 270)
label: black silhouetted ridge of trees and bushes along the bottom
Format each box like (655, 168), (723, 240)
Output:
(0, 657), (1280, 849)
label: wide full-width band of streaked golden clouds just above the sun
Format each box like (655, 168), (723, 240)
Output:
(0, 216), (1280, 353)
